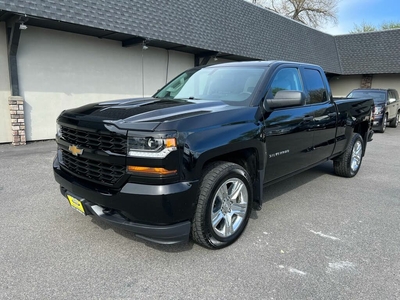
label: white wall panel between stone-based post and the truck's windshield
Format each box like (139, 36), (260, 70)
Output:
(18, 26), (193, 141)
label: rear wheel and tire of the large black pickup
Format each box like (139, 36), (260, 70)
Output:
(333, 133), (364, 177)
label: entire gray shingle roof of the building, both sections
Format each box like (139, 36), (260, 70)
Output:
(0, 0), (400, 74)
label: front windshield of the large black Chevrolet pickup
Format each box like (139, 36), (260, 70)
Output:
(153, 66), (266, 105)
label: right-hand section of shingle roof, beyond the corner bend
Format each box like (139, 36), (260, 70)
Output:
(335, 29), (400, 75)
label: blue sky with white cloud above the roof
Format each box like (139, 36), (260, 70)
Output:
(320, 0), (400, 35)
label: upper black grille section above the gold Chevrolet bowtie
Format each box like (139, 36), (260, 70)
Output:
(61, 126), (127, 155)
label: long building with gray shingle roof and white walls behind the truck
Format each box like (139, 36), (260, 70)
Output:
(0, 0), (400, 142)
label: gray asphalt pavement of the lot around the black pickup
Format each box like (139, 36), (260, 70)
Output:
(0, 128), (400, 300)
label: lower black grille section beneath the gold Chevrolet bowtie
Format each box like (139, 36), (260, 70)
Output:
(62, 150), (125, 185)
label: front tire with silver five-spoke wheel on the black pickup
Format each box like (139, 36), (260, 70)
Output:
(192, 162), (253, 249)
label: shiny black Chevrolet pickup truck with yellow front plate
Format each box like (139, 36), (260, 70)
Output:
(53, 61), (373, 248)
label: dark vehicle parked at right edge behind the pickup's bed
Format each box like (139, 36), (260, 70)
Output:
(347, 89), (400, 133)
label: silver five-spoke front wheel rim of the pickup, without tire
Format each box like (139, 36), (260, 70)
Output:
(211, 178), (249, 238)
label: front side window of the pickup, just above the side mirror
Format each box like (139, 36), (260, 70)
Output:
(270, 68), (303, 97)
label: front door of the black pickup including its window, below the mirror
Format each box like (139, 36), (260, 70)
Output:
(263, 66), (314, 182)
